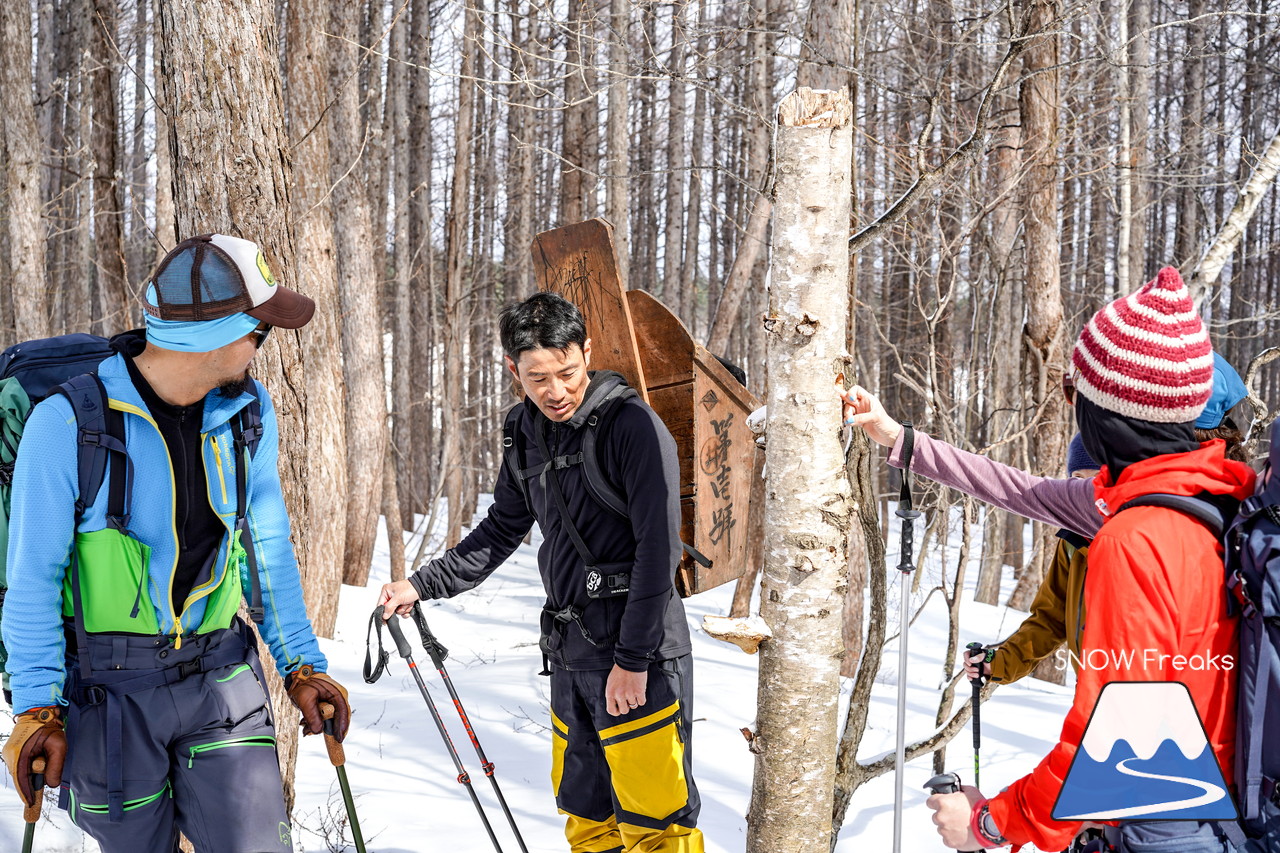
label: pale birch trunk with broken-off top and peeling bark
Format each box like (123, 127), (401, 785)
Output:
(746, 88), (854, 853)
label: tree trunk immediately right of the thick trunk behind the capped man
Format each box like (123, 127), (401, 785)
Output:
(285, 0), (347, 637)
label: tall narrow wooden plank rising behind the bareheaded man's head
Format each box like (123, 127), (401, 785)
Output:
(532, 219), (649, 394)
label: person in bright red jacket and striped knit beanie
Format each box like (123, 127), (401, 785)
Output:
(928, 268), (1254, 853)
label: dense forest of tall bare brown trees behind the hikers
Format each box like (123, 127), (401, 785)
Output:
(0, 0), (1280, 853)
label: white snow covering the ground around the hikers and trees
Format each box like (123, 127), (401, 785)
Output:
(0, 499), (1070, 853)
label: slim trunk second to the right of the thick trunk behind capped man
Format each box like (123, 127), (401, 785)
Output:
(329, 0), (387, 587)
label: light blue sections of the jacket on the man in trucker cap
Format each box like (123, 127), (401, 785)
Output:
(3, 355), (326, 711)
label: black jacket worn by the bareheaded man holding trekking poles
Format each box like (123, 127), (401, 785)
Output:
(410, 371), (691, 672)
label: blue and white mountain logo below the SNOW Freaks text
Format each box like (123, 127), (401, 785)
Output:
(1052, 681), (1238, 821)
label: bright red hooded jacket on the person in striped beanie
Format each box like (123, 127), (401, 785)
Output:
(991, 441), (1254, 850)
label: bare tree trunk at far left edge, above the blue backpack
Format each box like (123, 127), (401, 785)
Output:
(0, 3), (50, 341)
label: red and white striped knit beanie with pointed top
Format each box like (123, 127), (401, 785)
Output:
(1071, 266), (1213, 424)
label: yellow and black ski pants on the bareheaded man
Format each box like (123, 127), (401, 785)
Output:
(552, 654), (703, 853)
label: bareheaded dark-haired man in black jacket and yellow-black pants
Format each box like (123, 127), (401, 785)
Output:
(379, 293), (703, 853)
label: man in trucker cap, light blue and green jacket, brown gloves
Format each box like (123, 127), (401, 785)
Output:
(3, 234), (349, 853)
